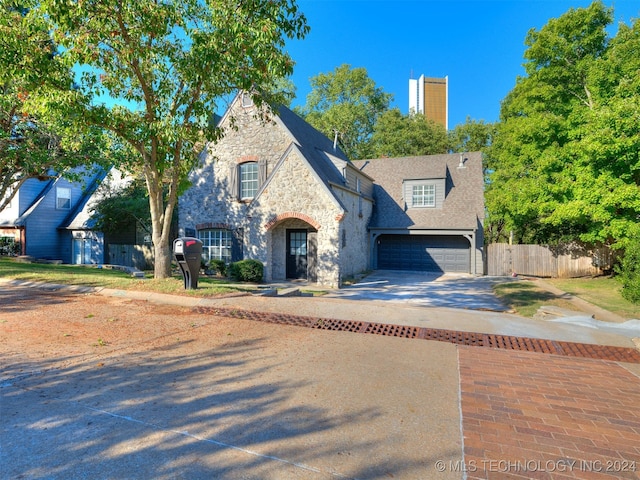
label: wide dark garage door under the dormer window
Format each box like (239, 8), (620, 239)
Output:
(378, 235), (471, 273)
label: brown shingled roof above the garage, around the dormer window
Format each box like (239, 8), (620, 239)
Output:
(353, 152), (484, 230)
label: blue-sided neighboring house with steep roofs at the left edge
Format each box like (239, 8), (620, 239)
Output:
(0, 169), (130, 264)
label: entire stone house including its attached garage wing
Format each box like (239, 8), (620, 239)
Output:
(178, 95), (484, 287)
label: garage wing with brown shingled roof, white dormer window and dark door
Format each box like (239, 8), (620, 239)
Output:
(353, 152), (484, 275)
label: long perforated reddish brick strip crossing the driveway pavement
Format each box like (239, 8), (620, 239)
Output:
(196, 307), (640, 363)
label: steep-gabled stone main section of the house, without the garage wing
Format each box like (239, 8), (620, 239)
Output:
(178, 95), (373, 286)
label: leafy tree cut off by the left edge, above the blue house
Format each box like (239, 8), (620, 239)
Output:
(0, 2), (104, 211)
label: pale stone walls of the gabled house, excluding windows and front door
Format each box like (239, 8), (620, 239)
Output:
(178, 98), (372, 287)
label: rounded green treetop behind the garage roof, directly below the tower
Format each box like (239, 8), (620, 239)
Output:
(370, 108), (448, 158)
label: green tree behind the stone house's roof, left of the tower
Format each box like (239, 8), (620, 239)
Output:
(295, 64), (393, 160)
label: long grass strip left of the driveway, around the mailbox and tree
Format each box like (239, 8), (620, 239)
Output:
(0, 257), (255, 297)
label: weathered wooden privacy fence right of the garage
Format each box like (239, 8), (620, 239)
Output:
(487, 243), (612, 278)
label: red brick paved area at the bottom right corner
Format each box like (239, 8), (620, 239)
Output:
(458, 347), (640, 480)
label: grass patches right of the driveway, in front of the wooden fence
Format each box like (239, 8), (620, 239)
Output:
(495, 277), (640, 318)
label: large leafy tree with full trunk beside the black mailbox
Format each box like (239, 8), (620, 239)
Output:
(35, 0), (308, 278)
